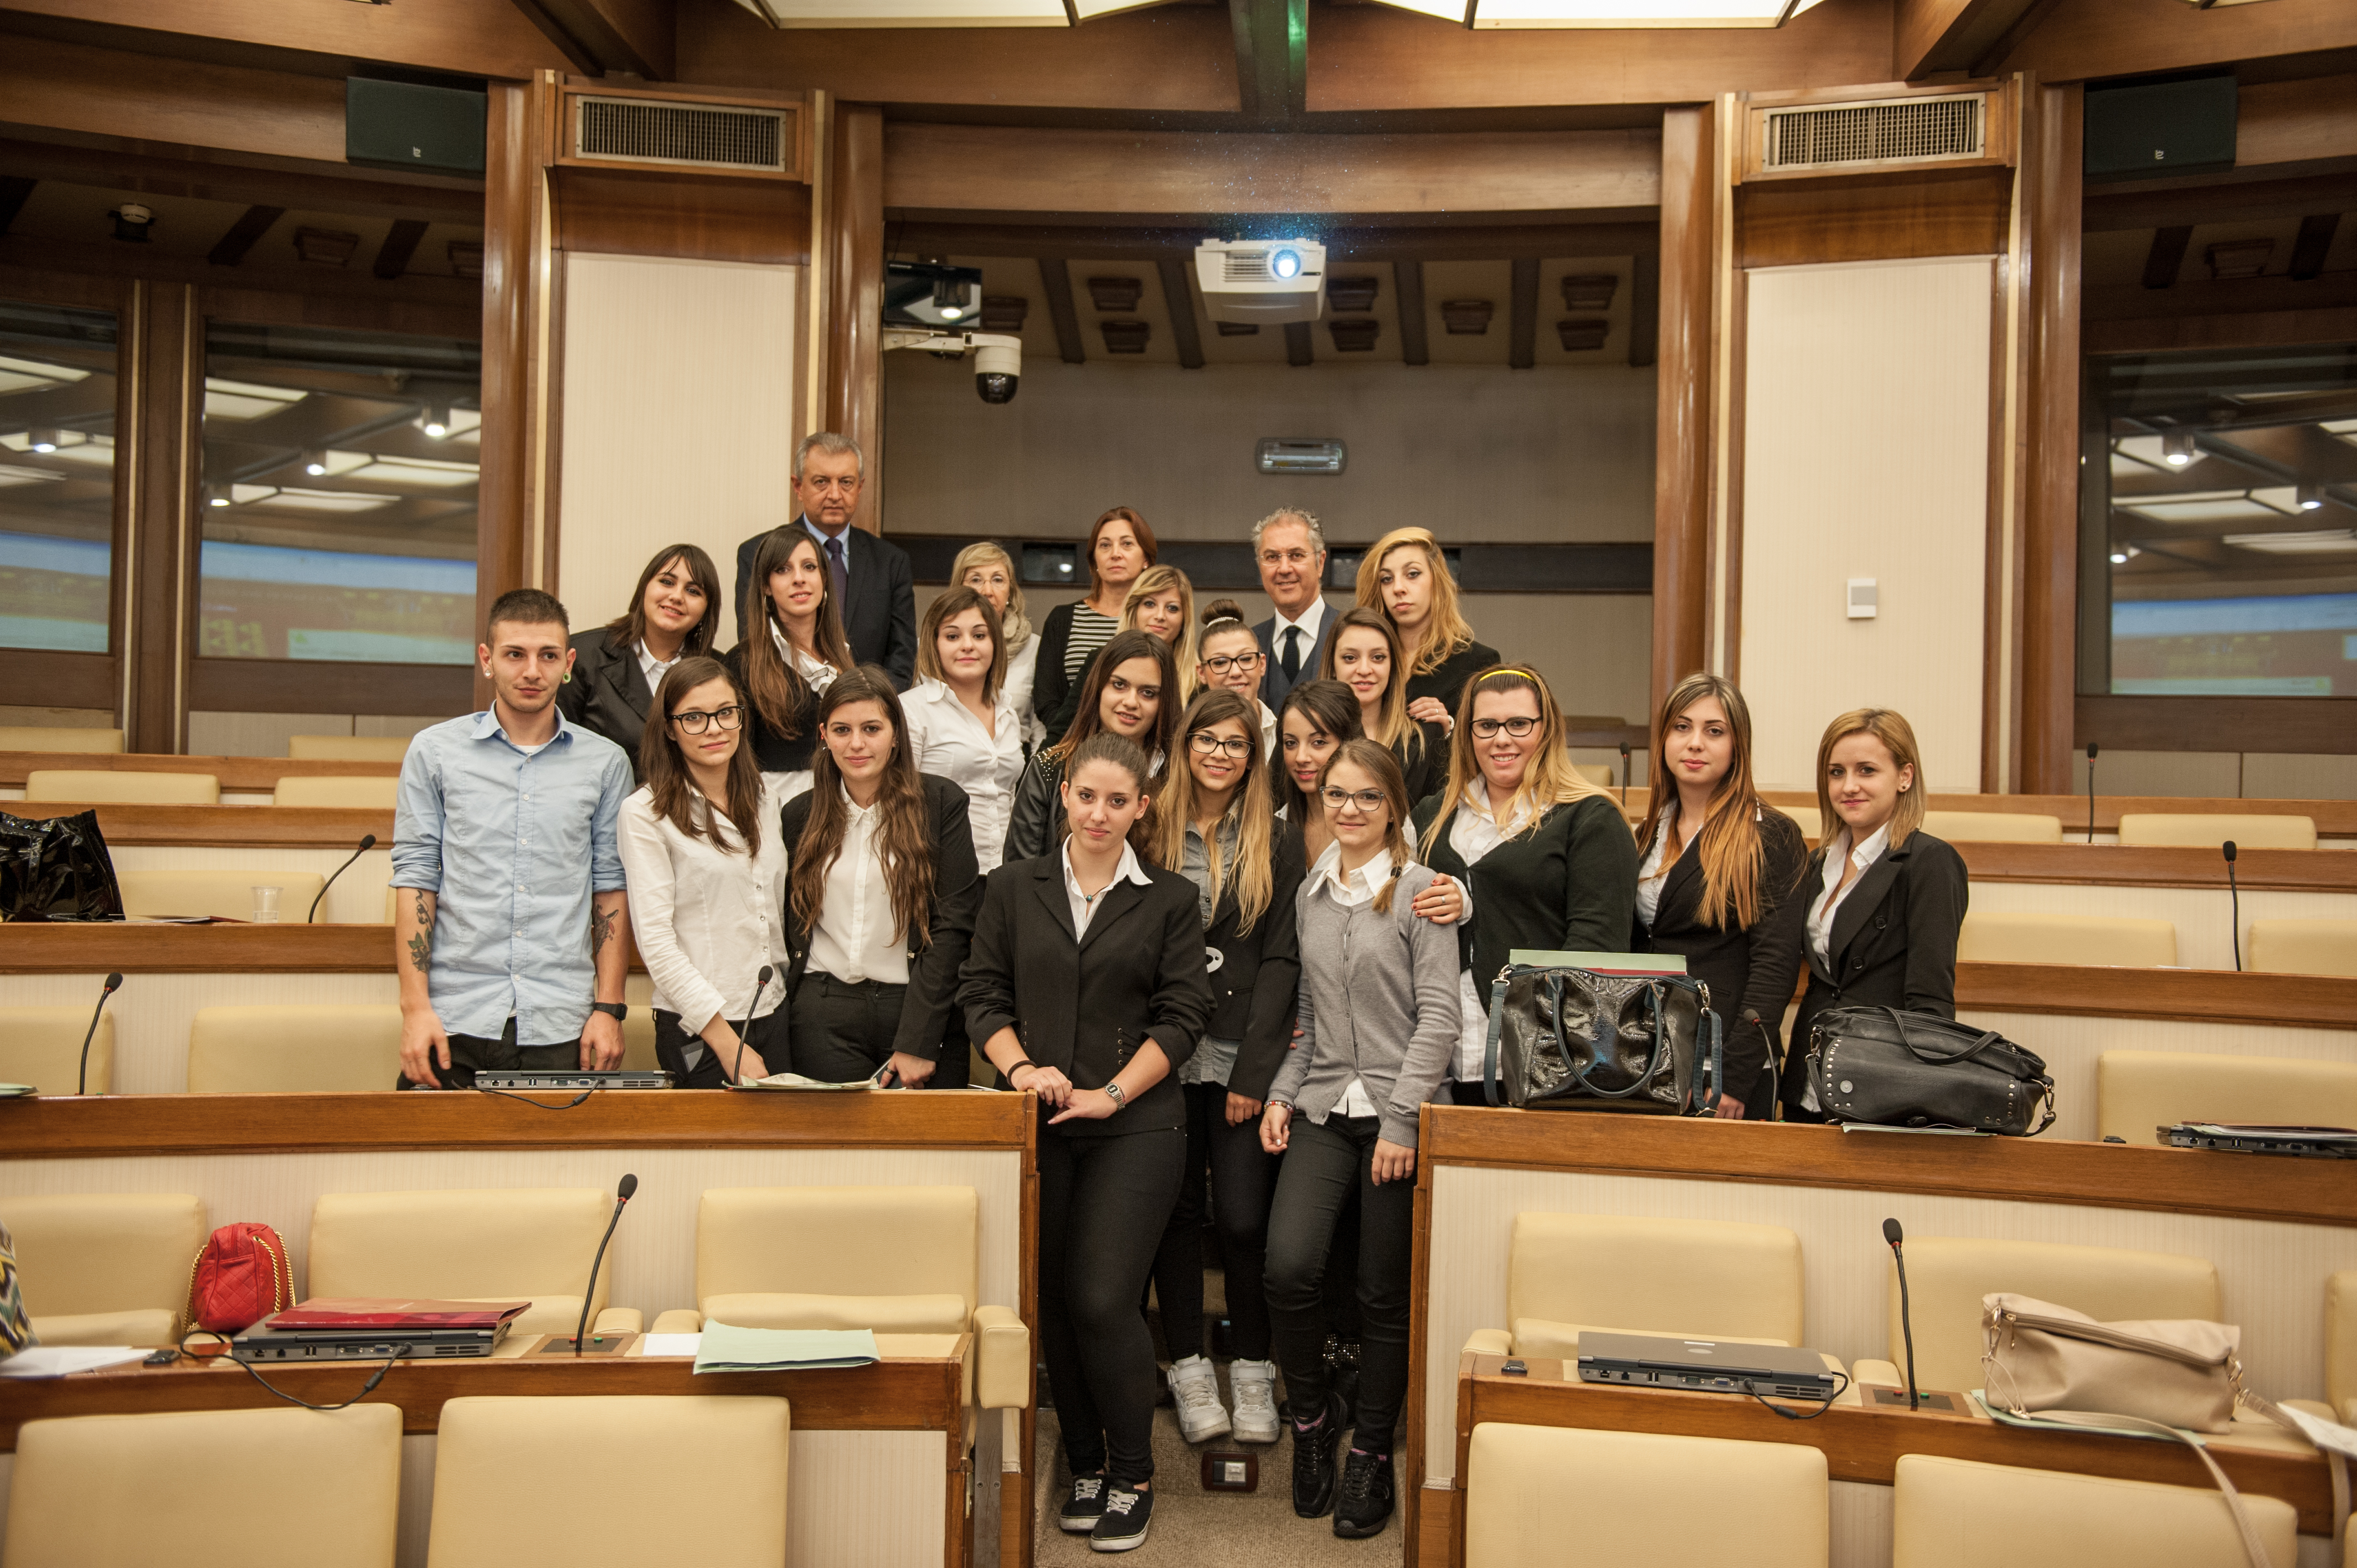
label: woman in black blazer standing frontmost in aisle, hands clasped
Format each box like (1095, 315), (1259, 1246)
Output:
(959, 733), (1212, 1551)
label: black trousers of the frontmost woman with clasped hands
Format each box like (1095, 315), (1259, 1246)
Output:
(1039, 1127), (1186, 1486)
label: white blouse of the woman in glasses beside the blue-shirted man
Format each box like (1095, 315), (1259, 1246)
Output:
(617, 773), (790, 1035)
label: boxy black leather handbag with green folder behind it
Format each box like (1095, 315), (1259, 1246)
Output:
(1483, 964), (1728, 1115)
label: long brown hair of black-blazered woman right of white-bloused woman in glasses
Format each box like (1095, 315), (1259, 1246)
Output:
(788, 665), (938, 943)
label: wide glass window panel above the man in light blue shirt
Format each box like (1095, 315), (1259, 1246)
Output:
(198, 321), (483, 665)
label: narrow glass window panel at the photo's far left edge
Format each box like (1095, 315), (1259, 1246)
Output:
(0, 300), (116, 653)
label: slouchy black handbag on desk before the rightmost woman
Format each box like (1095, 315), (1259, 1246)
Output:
(1808, 1007), (2055, 1139)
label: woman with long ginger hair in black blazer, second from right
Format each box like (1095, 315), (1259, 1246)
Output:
(1629, 674), (1808, 1120)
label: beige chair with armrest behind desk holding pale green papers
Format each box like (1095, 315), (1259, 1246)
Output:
(655, 1186), (1030, 1410)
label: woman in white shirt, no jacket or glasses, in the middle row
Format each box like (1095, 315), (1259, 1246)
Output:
(900, 587), (1023, 875)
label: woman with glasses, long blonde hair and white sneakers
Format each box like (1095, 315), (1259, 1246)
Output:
(1152, 686), (1301, 1443)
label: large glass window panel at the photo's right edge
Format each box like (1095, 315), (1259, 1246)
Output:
(2081, 344), (2357, 695)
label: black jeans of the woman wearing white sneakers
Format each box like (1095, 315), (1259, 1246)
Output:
(1155, 1085), (1278, 1360)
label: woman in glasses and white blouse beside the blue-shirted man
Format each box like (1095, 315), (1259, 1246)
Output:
(620, 656), (788, 1089)
